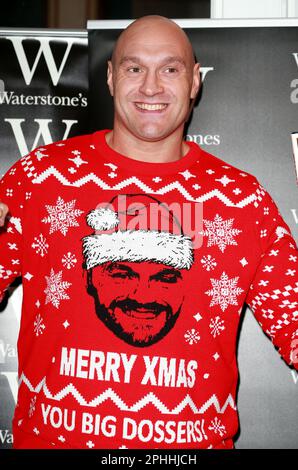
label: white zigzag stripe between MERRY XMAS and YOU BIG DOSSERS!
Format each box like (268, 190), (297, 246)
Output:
(19, 373), (237, 415)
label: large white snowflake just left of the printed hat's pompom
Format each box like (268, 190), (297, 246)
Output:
(42, 196), (84, 236)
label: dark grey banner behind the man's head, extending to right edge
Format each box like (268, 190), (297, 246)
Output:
(89, 20), (298, 448)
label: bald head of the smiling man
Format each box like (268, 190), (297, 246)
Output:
(108, 16), (200, 142)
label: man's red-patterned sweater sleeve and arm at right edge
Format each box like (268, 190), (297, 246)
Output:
(246, 182), (298, 369)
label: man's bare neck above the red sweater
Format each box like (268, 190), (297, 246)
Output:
(106, 128), (189, 163)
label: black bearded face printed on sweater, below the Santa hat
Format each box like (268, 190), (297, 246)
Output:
(92, 262), (183, 347)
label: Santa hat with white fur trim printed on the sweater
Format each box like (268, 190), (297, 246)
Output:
(83, 194), (193, 269)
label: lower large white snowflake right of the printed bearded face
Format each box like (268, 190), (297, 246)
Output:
(205, 272), (243, 312)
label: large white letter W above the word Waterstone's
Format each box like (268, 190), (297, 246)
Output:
(6, 36), (76, 86)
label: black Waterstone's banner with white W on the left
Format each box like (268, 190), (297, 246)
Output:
(0, 29), (88, 449)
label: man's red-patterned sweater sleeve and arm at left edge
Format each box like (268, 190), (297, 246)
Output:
(0, 162), (24, 302)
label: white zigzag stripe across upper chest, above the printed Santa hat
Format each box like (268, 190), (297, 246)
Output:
(32, 166), (259, 208)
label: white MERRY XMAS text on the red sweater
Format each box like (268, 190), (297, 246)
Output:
(60, 347), (198, 388)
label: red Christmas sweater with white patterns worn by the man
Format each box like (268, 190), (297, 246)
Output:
(0, 127), (298, 449)
